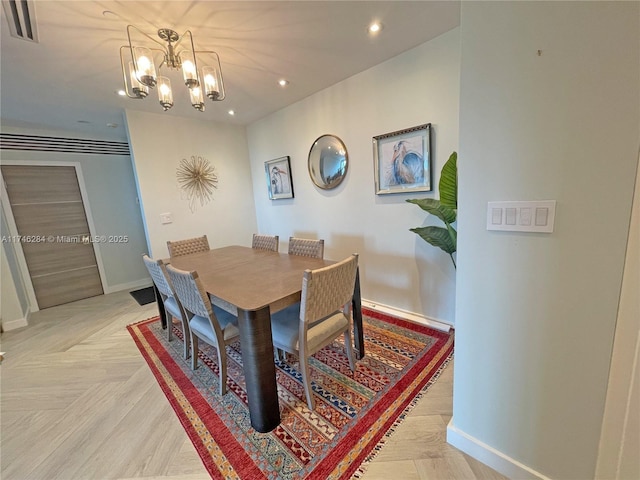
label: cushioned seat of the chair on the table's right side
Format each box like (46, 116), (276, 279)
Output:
(271, 303), (349, 352)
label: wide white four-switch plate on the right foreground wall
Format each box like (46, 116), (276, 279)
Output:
(487, 200), (556, 233)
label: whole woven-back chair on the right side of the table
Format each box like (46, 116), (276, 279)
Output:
(271, 254), (358, 410)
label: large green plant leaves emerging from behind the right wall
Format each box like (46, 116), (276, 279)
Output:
(407, 152), (458, 268)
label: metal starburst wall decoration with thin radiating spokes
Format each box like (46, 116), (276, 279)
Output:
(176, 155), (218, 213)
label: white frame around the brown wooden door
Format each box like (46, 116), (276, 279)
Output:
(0, 158), (107, 312)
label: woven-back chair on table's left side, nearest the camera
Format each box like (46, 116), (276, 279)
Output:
(167, 265), (240, 395)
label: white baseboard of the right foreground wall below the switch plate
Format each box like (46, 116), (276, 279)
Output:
(447, 418), (550, 480)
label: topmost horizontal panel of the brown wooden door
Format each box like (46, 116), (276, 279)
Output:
(2, 165), (82, 205)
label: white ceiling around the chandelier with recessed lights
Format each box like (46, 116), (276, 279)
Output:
(0, 0), (460, 139)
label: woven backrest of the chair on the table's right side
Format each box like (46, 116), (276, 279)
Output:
(300, 253), (358, 324)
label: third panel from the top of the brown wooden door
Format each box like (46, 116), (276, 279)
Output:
(22, 242), (96, 277)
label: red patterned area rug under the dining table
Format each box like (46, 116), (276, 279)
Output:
(127, 309), (453, 480)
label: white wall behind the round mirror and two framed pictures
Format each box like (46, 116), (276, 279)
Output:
(247, 29), (460, 323)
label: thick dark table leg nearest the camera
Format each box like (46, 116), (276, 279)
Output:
(238, 307), (280, 433)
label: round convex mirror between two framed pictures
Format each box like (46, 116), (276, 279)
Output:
(309, 135), (349, 190)
